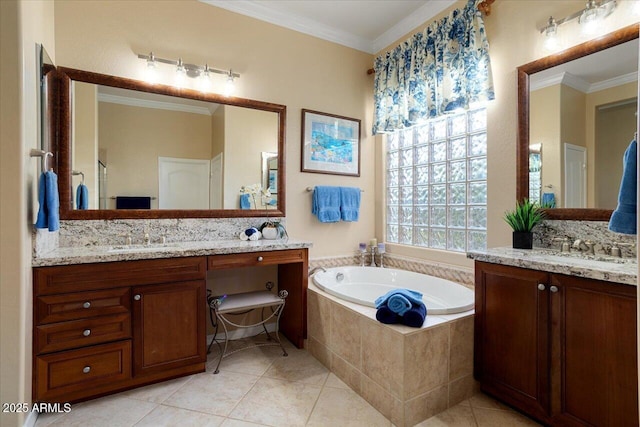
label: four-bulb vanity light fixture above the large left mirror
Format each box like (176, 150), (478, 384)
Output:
(137, 52), (240, 90)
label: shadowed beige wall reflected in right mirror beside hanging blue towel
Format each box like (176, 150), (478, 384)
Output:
(595, 98), (638, 209)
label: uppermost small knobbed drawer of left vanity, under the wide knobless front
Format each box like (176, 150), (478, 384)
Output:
(36, 288), (131, 325)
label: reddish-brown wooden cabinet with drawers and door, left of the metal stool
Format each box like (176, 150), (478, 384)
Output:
(33, 257), (206, 402)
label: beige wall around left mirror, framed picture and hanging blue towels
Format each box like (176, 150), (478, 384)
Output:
(55, 0), (375, 257)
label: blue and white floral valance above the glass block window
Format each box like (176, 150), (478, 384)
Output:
(373, 0), (494, 134)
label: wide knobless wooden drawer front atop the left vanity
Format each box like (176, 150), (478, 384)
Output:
(33, 257), (207, 296)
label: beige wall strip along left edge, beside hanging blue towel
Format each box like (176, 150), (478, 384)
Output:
(0, 0), (56, 426)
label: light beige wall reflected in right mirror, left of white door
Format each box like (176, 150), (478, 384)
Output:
(529, 85), (563, 205)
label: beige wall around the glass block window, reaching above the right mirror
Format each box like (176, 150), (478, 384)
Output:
(375, 0), (638, 268)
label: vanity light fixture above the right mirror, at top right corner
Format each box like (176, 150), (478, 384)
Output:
(540, 0), (617, 50)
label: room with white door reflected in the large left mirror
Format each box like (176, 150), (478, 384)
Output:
(71, 82), (278, 209)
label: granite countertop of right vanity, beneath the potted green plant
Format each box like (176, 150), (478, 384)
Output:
(467, 247), (638, 286)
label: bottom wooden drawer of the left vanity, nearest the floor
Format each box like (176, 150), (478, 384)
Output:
(35, 340), (131, 402)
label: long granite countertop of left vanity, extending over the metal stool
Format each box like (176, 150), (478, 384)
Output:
(32, 239), (313, 267)
